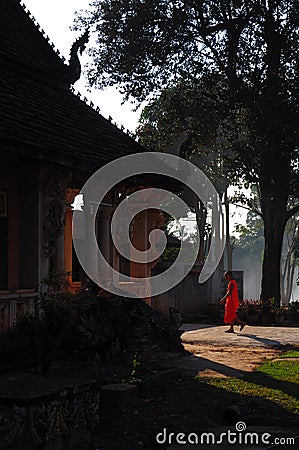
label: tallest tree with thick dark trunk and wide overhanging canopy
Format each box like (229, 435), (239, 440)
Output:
(75, 0), (299, 301)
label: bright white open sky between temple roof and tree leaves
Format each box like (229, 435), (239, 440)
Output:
(22, 0), (140, 131)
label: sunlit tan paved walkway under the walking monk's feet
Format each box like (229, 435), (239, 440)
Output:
(175, 324), (299, 378)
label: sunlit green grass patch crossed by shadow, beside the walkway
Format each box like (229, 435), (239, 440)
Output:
(198, 351), (299, 414)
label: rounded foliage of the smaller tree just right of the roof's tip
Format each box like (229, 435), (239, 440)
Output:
(137, 74), (259, 184)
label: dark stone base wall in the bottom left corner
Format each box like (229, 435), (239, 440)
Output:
(0, 384), (100, 450)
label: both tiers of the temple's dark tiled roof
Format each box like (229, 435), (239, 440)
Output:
(0, 0), (144, 167)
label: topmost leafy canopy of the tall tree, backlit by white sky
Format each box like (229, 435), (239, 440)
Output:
(74, 0), (299, 100)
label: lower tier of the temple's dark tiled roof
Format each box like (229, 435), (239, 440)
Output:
(0, 72), (144, 168)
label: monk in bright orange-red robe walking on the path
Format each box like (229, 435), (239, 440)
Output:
(219, 270), (245, 333)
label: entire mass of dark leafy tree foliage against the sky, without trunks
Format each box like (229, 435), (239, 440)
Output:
(74, 0), (299, 194)
